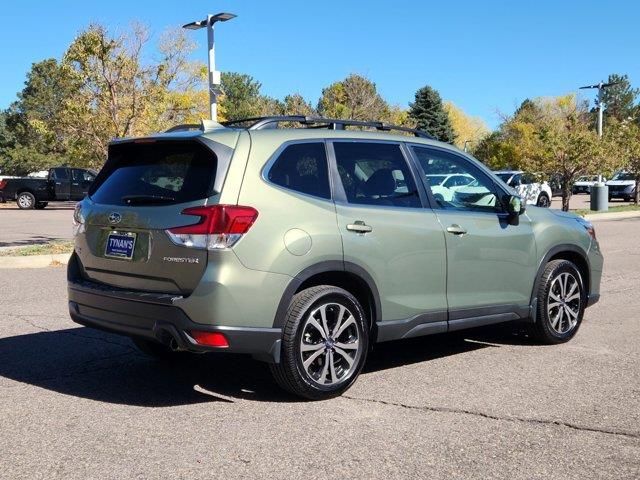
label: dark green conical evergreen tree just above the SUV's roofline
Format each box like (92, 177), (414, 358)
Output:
(409, 85), (456, 143)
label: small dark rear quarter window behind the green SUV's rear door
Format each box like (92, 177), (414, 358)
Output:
(268, 142), (331, 198)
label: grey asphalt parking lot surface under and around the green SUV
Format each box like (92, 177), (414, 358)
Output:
(0, 218), (640, 480)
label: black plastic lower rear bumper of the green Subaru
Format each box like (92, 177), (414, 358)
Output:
(68, 280), (282, 363)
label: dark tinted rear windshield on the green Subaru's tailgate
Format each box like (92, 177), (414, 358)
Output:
(89, 142), (217, 205)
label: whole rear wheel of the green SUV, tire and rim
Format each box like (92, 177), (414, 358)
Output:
(271, 285), (369, 400)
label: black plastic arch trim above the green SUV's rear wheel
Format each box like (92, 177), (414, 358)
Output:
(273, 260), (381, 328)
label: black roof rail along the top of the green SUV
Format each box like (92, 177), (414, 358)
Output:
(222, 115), (435, 140)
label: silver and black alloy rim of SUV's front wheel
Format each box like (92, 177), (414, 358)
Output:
(547, 272), (582, 335)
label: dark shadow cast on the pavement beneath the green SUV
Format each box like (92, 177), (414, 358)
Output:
(0, 322), (528, 407)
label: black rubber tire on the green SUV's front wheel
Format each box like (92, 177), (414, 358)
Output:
(532, 260), (586, 345)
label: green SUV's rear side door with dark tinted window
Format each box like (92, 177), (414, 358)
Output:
(329, 141), (446, 321)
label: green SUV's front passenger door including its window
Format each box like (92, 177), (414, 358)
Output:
(410, 145), (537, 316)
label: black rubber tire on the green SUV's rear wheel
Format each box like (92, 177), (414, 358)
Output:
(270, 285), (369, 400)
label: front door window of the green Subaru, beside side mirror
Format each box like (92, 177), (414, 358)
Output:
(411, 146), (500, 212)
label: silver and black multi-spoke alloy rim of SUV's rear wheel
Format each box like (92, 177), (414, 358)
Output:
(299, 303), (362, 386)
